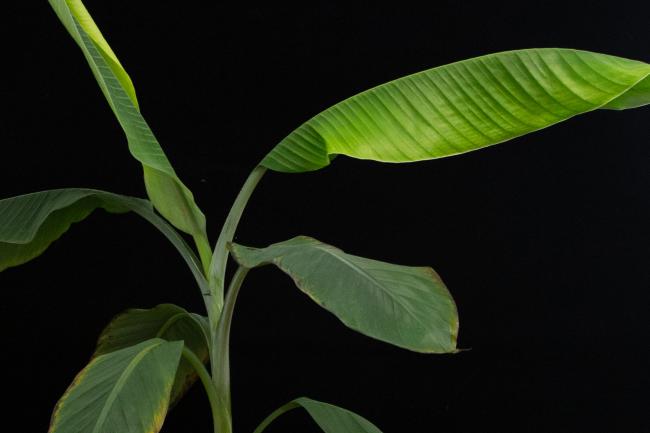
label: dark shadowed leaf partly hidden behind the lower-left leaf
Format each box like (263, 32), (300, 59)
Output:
(93, 304), (210, 406)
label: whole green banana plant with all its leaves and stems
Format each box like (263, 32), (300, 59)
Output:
(0, 0), (650, 433)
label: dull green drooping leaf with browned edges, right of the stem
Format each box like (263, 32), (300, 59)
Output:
(230, 236), (458, 353)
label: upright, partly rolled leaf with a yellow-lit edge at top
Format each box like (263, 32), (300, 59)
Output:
(49, 0), (206, 239)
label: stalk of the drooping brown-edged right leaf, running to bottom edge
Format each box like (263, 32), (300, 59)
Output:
(211, 266), (249, 433)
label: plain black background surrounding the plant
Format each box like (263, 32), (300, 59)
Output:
(0, 0), (650, 433)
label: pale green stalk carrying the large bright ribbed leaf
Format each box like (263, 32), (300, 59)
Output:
(207, 165), (266, 311)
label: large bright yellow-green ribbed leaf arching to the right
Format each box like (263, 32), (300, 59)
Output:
(261, 48), (650, 172)
